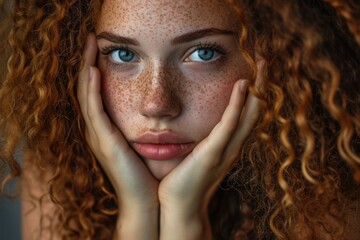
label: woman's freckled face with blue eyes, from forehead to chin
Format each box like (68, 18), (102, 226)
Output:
(96, 0), (249, 179)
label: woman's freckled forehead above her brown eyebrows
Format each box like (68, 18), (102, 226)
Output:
(97, 0), (239, 34)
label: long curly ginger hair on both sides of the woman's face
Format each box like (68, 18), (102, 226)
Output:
(0, 0), (360, 239)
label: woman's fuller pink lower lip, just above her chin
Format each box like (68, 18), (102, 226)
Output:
(134, 143), (194, 160)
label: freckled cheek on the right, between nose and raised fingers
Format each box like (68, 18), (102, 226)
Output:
(184, 56), (250, 138)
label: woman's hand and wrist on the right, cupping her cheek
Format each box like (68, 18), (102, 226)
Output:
(159, 63), (260, 239)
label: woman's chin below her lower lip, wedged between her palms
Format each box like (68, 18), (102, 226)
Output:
(145, 159), (182, 181)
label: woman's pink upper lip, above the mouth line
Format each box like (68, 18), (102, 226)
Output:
(134, 131), (192, 144)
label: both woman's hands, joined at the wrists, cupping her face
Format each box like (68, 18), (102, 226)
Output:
(78, 31), (262, 239)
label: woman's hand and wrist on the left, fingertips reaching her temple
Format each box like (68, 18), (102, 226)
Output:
(78, 34), (159, 239)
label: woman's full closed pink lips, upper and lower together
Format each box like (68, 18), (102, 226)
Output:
(133, 131), (194, 160)
